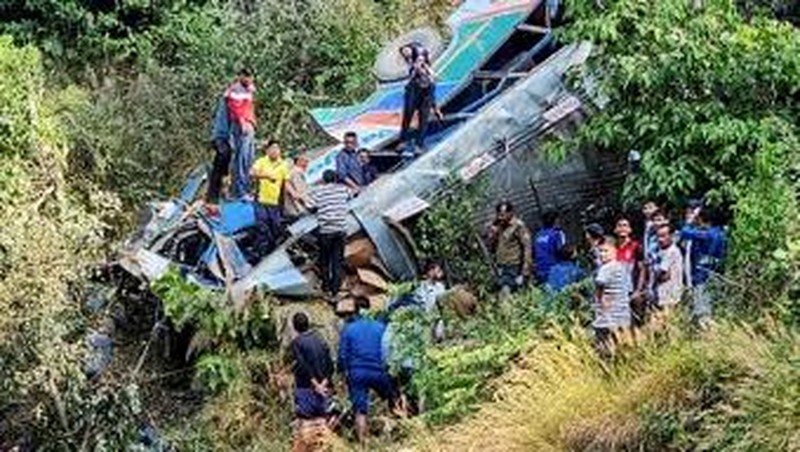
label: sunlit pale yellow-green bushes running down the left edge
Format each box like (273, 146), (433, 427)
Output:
(0, 37), (139, 450)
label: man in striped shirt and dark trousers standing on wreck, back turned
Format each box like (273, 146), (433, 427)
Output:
(310, 170), (350, 300)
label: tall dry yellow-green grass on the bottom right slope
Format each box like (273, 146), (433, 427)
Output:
(410, 324), (800, 451)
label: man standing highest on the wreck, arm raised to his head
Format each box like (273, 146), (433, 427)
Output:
(400, 43), (442, 152)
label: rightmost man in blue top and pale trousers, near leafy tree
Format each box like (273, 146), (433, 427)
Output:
(680, 208), (727, 326)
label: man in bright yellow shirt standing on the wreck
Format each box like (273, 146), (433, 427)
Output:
(250, 140), (289, 251)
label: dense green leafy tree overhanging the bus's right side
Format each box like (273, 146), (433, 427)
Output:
(555, 0), (800, 310)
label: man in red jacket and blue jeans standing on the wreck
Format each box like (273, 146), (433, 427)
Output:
(225, 68), (256, 199)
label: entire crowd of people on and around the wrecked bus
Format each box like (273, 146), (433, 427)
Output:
(206, 51), (726, 450)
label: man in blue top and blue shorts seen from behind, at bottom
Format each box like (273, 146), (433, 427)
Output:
(339, 297), (397, 445)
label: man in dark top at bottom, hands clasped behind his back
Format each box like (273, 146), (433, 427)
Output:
(290, 312), (333, 450)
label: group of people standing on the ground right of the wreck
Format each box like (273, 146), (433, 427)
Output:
(486, 201), (727, 353)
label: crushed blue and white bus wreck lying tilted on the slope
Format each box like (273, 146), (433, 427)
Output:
(116, 0), (591, 308)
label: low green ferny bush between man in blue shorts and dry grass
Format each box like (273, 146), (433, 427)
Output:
(392, 289), (575, 425)
